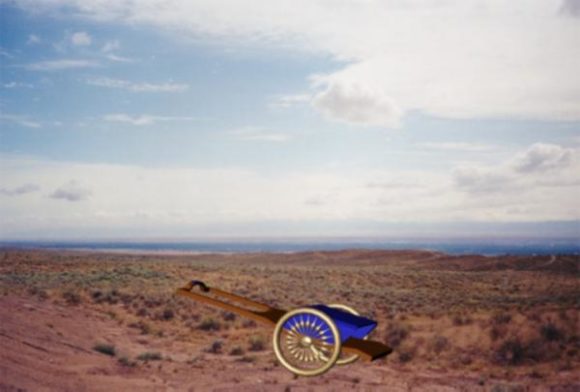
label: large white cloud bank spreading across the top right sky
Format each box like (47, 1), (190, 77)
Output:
(10, 0), (580, 126)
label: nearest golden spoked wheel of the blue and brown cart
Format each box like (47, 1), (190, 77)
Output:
(273, 308), (341, 376)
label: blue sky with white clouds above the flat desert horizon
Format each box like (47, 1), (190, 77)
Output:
(0, 0), (580, 240)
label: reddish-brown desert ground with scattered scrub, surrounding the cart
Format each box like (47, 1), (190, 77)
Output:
(0, 249), (580, 392)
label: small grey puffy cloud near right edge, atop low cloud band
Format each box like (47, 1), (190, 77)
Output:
(513, 143), (573, 173)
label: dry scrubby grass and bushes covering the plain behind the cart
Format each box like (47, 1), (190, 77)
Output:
(0, 250), (580, 377)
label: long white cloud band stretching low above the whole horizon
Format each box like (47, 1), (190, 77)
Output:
(0, 149), (580, 236)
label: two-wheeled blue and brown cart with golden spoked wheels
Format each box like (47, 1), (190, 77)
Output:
(177, 280), (392, 376)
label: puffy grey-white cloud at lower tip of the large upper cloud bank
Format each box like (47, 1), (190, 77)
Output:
(313, 80), (402, 128)
